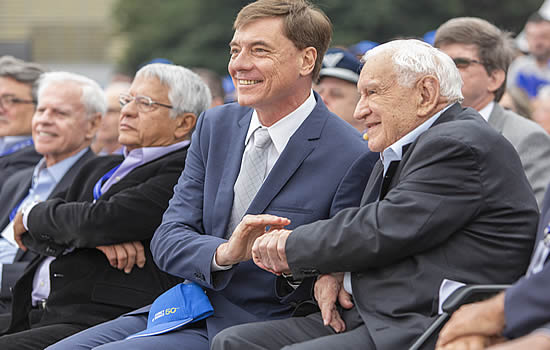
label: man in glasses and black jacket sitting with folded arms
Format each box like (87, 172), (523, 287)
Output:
(0, 64), (211, 349)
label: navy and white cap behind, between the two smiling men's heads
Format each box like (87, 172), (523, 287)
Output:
(319, 48), (362, 84)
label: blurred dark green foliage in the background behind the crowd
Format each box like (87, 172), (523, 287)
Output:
(113, 0), (543, 74)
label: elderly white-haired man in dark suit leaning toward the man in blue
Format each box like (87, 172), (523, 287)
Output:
(212, 40), (538, 350)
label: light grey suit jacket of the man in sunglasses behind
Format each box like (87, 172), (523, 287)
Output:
(489, 103), (550, 208)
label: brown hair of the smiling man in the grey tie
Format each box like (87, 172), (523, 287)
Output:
(233, 0), (332, 81)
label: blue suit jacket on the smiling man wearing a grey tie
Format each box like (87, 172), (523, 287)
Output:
(151, 94), (378, 339)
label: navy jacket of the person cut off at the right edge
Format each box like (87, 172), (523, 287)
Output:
(504, 187), (550, 338)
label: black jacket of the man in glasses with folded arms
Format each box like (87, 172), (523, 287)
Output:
(4, 148), (187, 332)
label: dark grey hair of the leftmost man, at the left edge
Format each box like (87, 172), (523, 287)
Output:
(0, 56), (45, 101)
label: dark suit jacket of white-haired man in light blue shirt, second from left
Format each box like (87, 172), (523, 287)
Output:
(0, 149), (95, 302)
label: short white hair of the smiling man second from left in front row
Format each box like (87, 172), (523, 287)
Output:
(38, 72), (107, 117)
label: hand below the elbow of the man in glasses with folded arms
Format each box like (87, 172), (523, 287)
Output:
(97, 241), (145, 273)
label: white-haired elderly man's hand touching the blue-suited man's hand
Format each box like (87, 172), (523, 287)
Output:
(252, 229), (292, 275)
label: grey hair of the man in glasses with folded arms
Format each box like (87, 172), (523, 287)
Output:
(136, 63), (212, 118)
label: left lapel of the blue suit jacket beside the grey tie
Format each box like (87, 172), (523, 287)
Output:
(212, 109), (252, 237)
